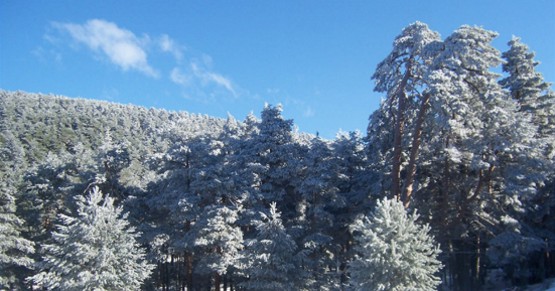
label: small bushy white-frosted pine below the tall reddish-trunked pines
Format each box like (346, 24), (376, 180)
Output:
(349, 198), (442, 291)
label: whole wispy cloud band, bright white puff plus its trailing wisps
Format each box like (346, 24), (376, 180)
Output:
(49, 19), (243, 102)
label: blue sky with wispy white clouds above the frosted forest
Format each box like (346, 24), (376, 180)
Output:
(0, 0), (555, 138)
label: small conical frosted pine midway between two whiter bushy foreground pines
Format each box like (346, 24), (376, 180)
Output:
(240, 202), (302, 290)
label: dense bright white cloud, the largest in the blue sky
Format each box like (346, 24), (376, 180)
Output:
(54, 19), (158, 77)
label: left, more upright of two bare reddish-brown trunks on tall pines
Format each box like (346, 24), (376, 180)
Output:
(391, 60), (412, 198)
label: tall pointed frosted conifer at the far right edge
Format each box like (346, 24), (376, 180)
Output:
(487, 37), (555, 284)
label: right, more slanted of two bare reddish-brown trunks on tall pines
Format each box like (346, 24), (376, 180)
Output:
(402, 93), (430, 208)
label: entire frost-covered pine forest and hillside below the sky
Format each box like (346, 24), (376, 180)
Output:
(0, 22), (555, 290)
